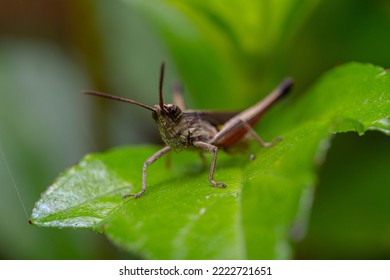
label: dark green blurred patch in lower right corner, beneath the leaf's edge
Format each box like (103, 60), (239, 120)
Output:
(296, 132), (390, 260)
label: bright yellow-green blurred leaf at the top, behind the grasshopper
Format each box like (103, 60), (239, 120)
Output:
(124, 0), (318, 109)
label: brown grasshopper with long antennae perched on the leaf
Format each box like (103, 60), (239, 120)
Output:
(82, 62), (293, 198)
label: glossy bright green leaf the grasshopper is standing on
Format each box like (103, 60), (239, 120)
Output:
(31, 63), (390, 259)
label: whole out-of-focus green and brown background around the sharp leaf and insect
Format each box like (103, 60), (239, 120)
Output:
(0, 0), (390, 259)
